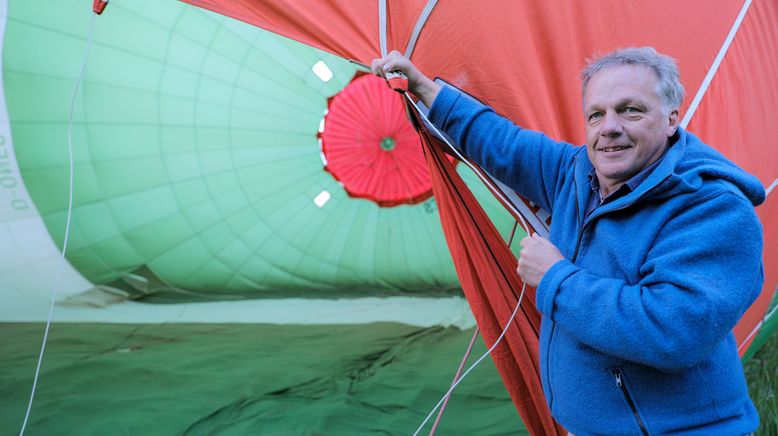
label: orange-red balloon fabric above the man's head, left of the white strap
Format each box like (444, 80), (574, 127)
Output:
(185, 0), (741, 143)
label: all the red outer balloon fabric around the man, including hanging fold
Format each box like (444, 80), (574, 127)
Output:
(179, 0), (778, 434)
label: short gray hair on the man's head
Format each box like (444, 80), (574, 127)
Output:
(581, 47), (684, 113)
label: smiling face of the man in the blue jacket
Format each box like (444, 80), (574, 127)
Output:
(583, 65), (678, 195)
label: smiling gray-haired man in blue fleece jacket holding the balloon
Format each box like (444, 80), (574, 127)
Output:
(373, 48), (765, 436)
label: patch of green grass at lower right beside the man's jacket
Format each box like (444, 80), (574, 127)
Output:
(743, 334), (778, 436)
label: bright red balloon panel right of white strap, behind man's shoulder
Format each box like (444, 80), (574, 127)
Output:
(689, 1), (778, 355)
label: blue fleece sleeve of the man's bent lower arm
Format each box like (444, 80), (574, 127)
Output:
(537, 191), (763, 372)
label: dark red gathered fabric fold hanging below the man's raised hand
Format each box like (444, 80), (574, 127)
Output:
(412, 113), (567, 435)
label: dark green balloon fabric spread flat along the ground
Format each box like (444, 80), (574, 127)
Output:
(0, 323), (526, 436)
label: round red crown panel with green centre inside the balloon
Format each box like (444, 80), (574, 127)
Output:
(319, 74), (432, 207)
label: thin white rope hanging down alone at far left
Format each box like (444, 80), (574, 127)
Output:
(19, 10), (97, 436)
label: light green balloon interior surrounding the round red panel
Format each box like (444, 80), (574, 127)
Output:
(3, 0), (511, 301)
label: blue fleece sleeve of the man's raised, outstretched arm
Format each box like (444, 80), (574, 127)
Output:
(430, 86), (575, 212)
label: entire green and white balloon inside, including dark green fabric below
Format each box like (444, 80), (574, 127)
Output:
(0, 0), (522, 435)
